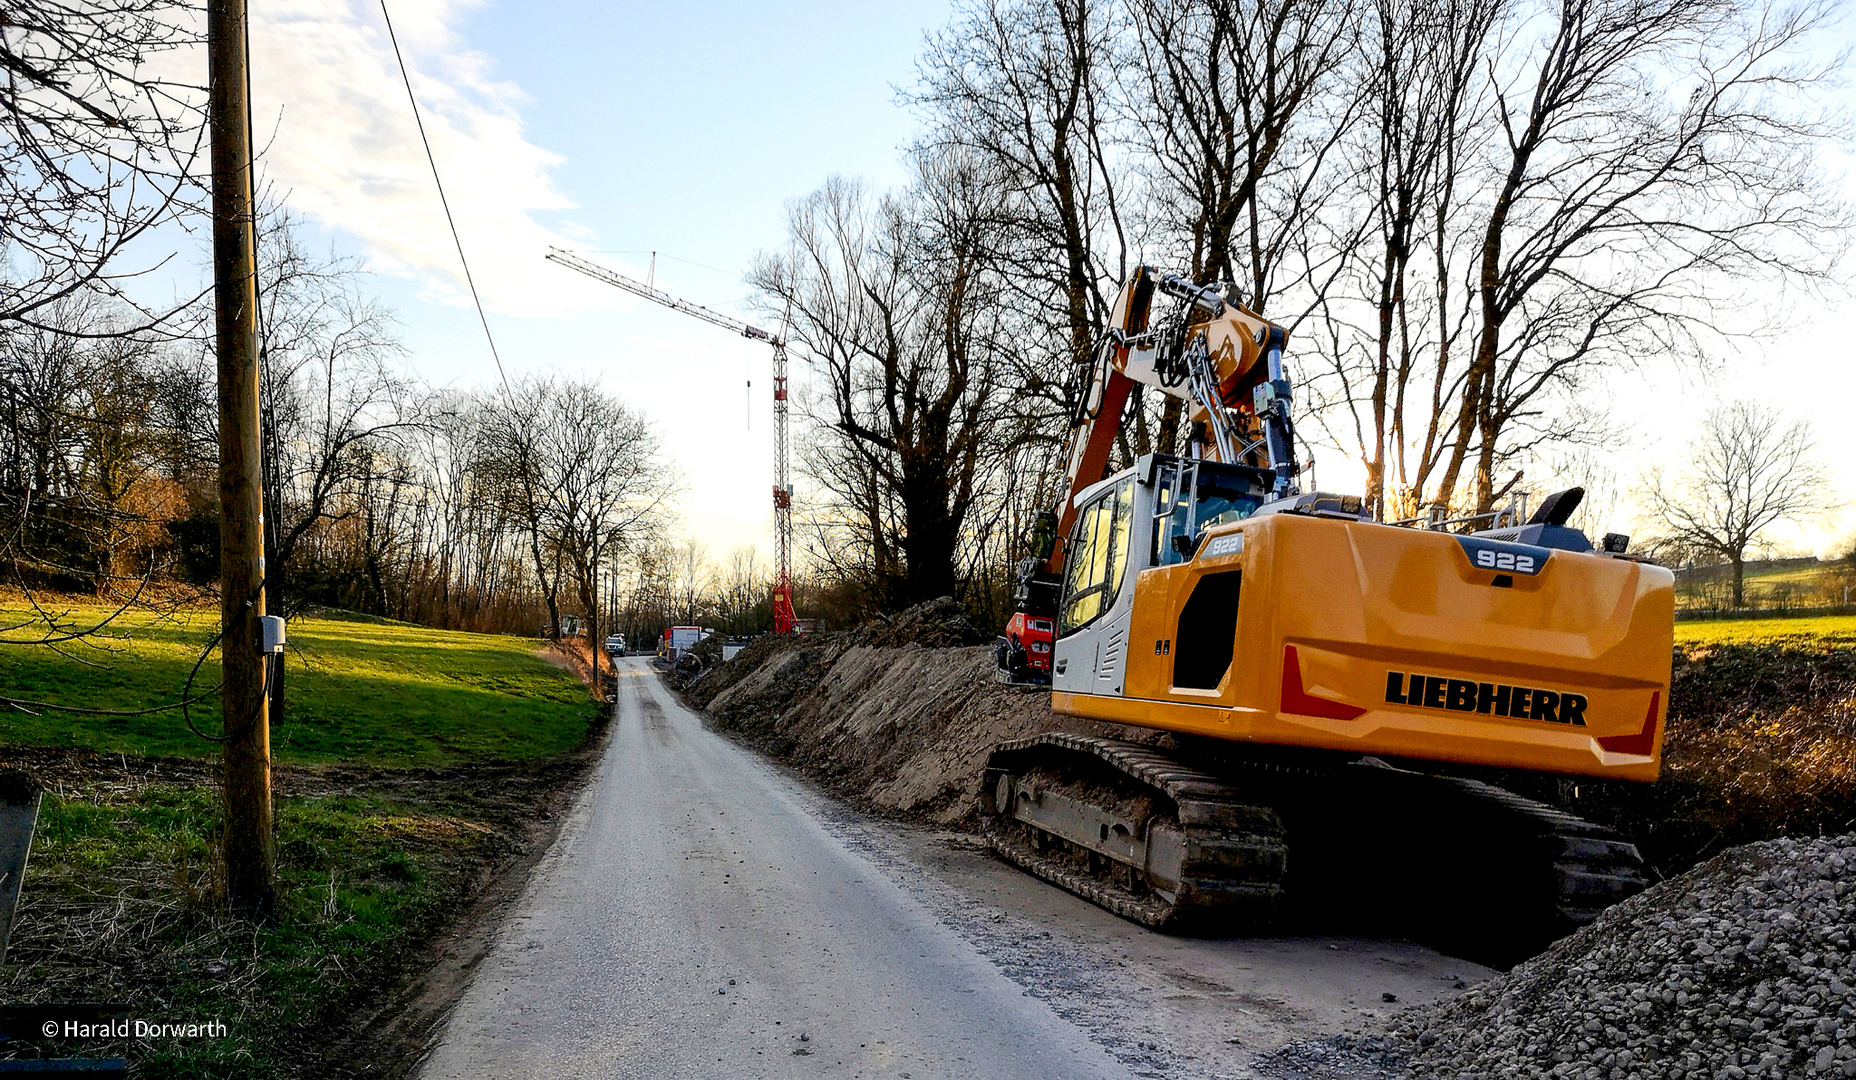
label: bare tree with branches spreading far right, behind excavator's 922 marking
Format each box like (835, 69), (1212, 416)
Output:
(1437, 0), (1843, 510)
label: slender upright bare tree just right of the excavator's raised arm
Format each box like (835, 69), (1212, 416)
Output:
(1305, 0), (1502, 518)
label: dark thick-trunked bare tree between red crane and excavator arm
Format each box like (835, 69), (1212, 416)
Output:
(754, 165), (1010, 603)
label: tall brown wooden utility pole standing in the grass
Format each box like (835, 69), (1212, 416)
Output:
(206, 0), (277, 919)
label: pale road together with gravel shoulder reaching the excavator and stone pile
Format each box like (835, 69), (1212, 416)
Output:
(425, 661), (1487, 1078)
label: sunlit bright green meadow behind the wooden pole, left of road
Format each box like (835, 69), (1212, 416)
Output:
(0, 605), (594, 766)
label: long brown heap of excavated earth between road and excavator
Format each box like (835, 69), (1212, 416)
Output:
(685, 599), (1160, 824)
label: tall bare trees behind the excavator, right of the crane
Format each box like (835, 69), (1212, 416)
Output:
(752, 0), (1849, 627)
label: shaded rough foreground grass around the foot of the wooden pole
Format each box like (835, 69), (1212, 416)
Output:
(0, 785), (499, 1078)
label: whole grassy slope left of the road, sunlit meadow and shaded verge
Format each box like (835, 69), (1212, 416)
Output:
(0, 611), (596, 1076)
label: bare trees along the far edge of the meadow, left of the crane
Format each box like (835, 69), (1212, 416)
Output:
(0, 210), (676, 649)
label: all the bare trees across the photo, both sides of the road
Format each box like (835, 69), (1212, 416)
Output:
(0, 0), (1849, 638)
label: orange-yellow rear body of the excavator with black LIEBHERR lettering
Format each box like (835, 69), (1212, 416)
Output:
(1052, 514), (1674, 781)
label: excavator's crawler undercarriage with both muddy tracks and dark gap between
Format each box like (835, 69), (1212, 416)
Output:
(982, 733), (1644, 963)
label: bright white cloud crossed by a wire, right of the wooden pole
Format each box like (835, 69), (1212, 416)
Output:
(251, 0), (629, 315)
